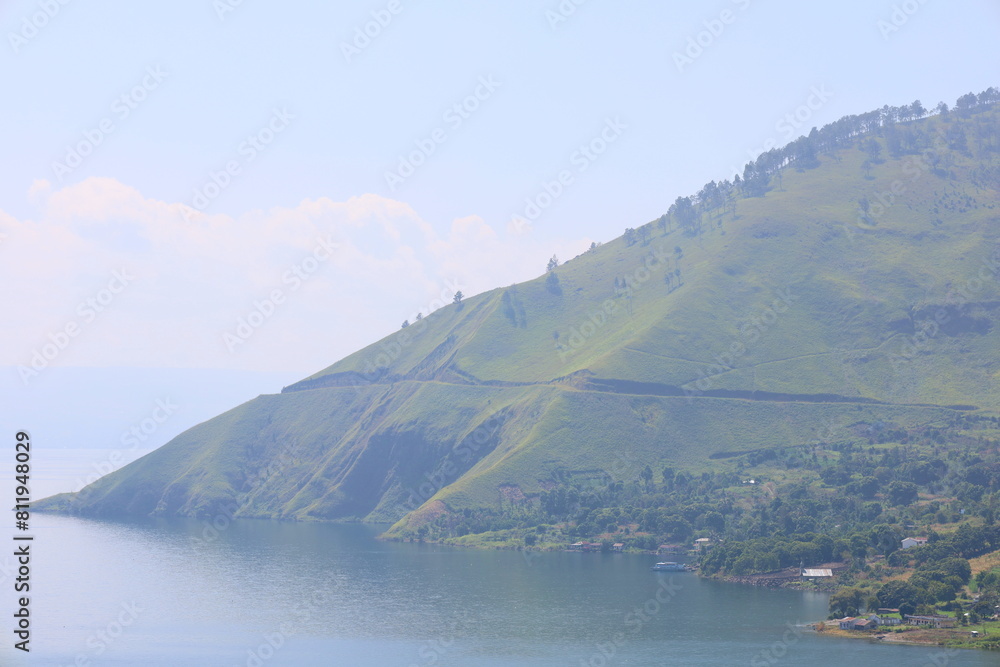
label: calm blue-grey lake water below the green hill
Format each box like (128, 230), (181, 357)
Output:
(0, 514), (1000, 667)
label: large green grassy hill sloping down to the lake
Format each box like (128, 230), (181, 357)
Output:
(36, 89), (1000, 544)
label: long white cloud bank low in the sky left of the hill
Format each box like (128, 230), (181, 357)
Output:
(0, 178), (589, 372)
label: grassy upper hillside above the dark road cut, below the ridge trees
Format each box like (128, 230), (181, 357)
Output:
(313, 112), (1000, 406)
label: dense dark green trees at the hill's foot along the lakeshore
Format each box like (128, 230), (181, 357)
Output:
(408, 416), (1000, 607)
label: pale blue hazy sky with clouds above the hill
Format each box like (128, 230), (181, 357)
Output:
(0, 0), (1000, 474)
